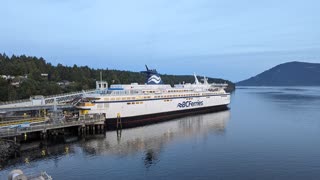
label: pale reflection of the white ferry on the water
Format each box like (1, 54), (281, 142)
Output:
(81, 110), (230, 167)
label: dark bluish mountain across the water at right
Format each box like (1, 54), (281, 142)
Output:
(236, 61), (320, 86)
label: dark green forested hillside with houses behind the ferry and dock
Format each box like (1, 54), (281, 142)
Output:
(0, 53), (234, 101)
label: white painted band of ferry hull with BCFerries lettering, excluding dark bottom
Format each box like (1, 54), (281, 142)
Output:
(91, 94), (230, 119)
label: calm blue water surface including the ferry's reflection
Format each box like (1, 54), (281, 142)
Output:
(0, 87), (320, 180)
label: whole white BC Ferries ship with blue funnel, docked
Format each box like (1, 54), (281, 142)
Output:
(77, 66), (230, 128)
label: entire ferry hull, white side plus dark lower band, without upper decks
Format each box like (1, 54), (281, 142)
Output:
(79, 94), (230, 129)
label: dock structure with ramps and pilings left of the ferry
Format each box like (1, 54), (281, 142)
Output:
(0, 90), (109, 140)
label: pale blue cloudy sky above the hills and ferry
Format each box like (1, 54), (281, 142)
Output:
(0, 0), (320, 82)
